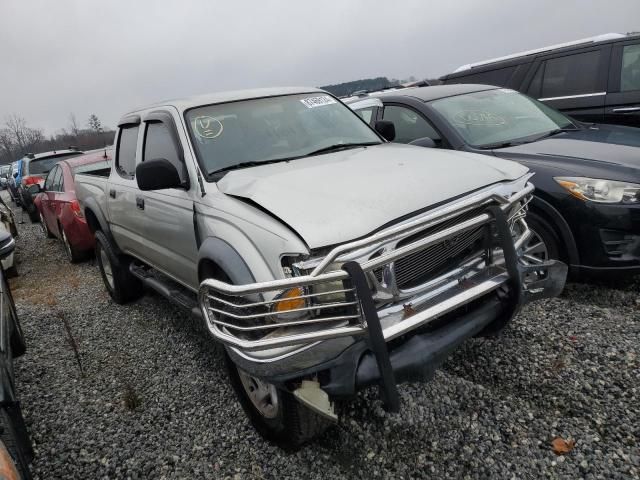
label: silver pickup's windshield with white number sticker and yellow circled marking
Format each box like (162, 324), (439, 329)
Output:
(186, 92), (382, 174)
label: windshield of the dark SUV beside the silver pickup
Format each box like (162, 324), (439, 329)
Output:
(431, 89), (576, 148)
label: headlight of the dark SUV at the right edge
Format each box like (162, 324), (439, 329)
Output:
(553, 177), (640, 204)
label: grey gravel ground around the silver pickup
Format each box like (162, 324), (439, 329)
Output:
(6, 192), (640, 479)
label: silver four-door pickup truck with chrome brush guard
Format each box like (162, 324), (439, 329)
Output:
(75, 88), (566, 445)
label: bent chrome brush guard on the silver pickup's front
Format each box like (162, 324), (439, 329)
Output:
(199, 180), (566, 356)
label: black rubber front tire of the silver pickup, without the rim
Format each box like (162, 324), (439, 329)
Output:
(225, 352), (331, 450)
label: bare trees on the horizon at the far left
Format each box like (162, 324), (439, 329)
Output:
(0, 113), (115, 164)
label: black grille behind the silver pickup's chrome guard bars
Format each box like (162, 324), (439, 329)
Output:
(394, 207), (487, 290)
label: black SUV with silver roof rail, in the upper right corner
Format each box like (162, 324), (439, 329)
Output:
(440, 33), (640, 127)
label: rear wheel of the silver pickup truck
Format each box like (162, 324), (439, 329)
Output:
(96, 230), (144, 304)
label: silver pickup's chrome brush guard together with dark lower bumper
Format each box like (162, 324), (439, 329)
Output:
(199, 178), (567, 410)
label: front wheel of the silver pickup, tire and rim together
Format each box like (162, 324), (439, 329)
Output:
(225, 353), (331, 449)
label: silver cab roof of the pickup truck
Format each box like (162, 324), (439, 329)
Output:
(127, 87), (324, 115)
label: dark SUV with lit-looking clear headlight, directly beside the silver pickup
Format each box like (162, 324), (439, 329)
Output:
(345, 85), (640, 276)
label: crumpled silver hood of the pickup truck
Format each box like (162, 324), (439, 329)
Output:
(218, 144), (528, 249)
